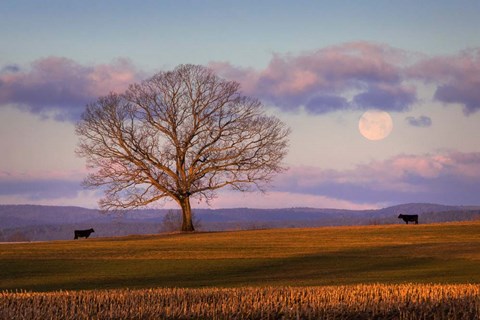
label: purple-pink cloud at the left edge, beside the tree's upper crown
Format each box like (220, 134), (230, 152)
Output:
(0, 57), (140, 121)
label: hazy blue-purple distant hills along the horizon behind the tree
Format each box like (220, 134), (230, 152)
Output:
(0, 203), (480, 241)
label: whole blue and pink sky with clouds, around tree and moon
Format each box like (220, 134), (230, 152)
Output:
(0, 0), (480, 209)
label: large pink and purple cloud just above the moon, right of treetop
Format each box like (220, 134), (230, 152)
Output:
(210, 42), (416, 114)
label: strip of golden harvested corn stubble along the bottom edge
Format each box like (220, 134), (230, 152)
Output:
(0, 284), (480, 319)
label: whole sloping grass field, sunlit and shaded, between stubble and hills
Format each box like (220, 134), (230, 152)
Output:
(0, 222), (480, 291)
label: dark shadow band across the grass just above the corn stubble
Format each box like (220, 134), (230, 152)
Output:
(0, 241), (480, 291)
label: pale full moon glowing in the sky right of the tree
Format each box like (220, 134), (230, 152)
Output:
(358, 110), (393, 140)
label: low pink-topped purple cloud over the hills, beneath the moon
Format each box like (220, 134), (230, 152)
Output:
(275, 152), (480, 205)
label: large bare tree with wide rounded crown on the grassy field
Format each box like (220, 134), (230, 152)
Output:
(76, 65), (290, 231)
